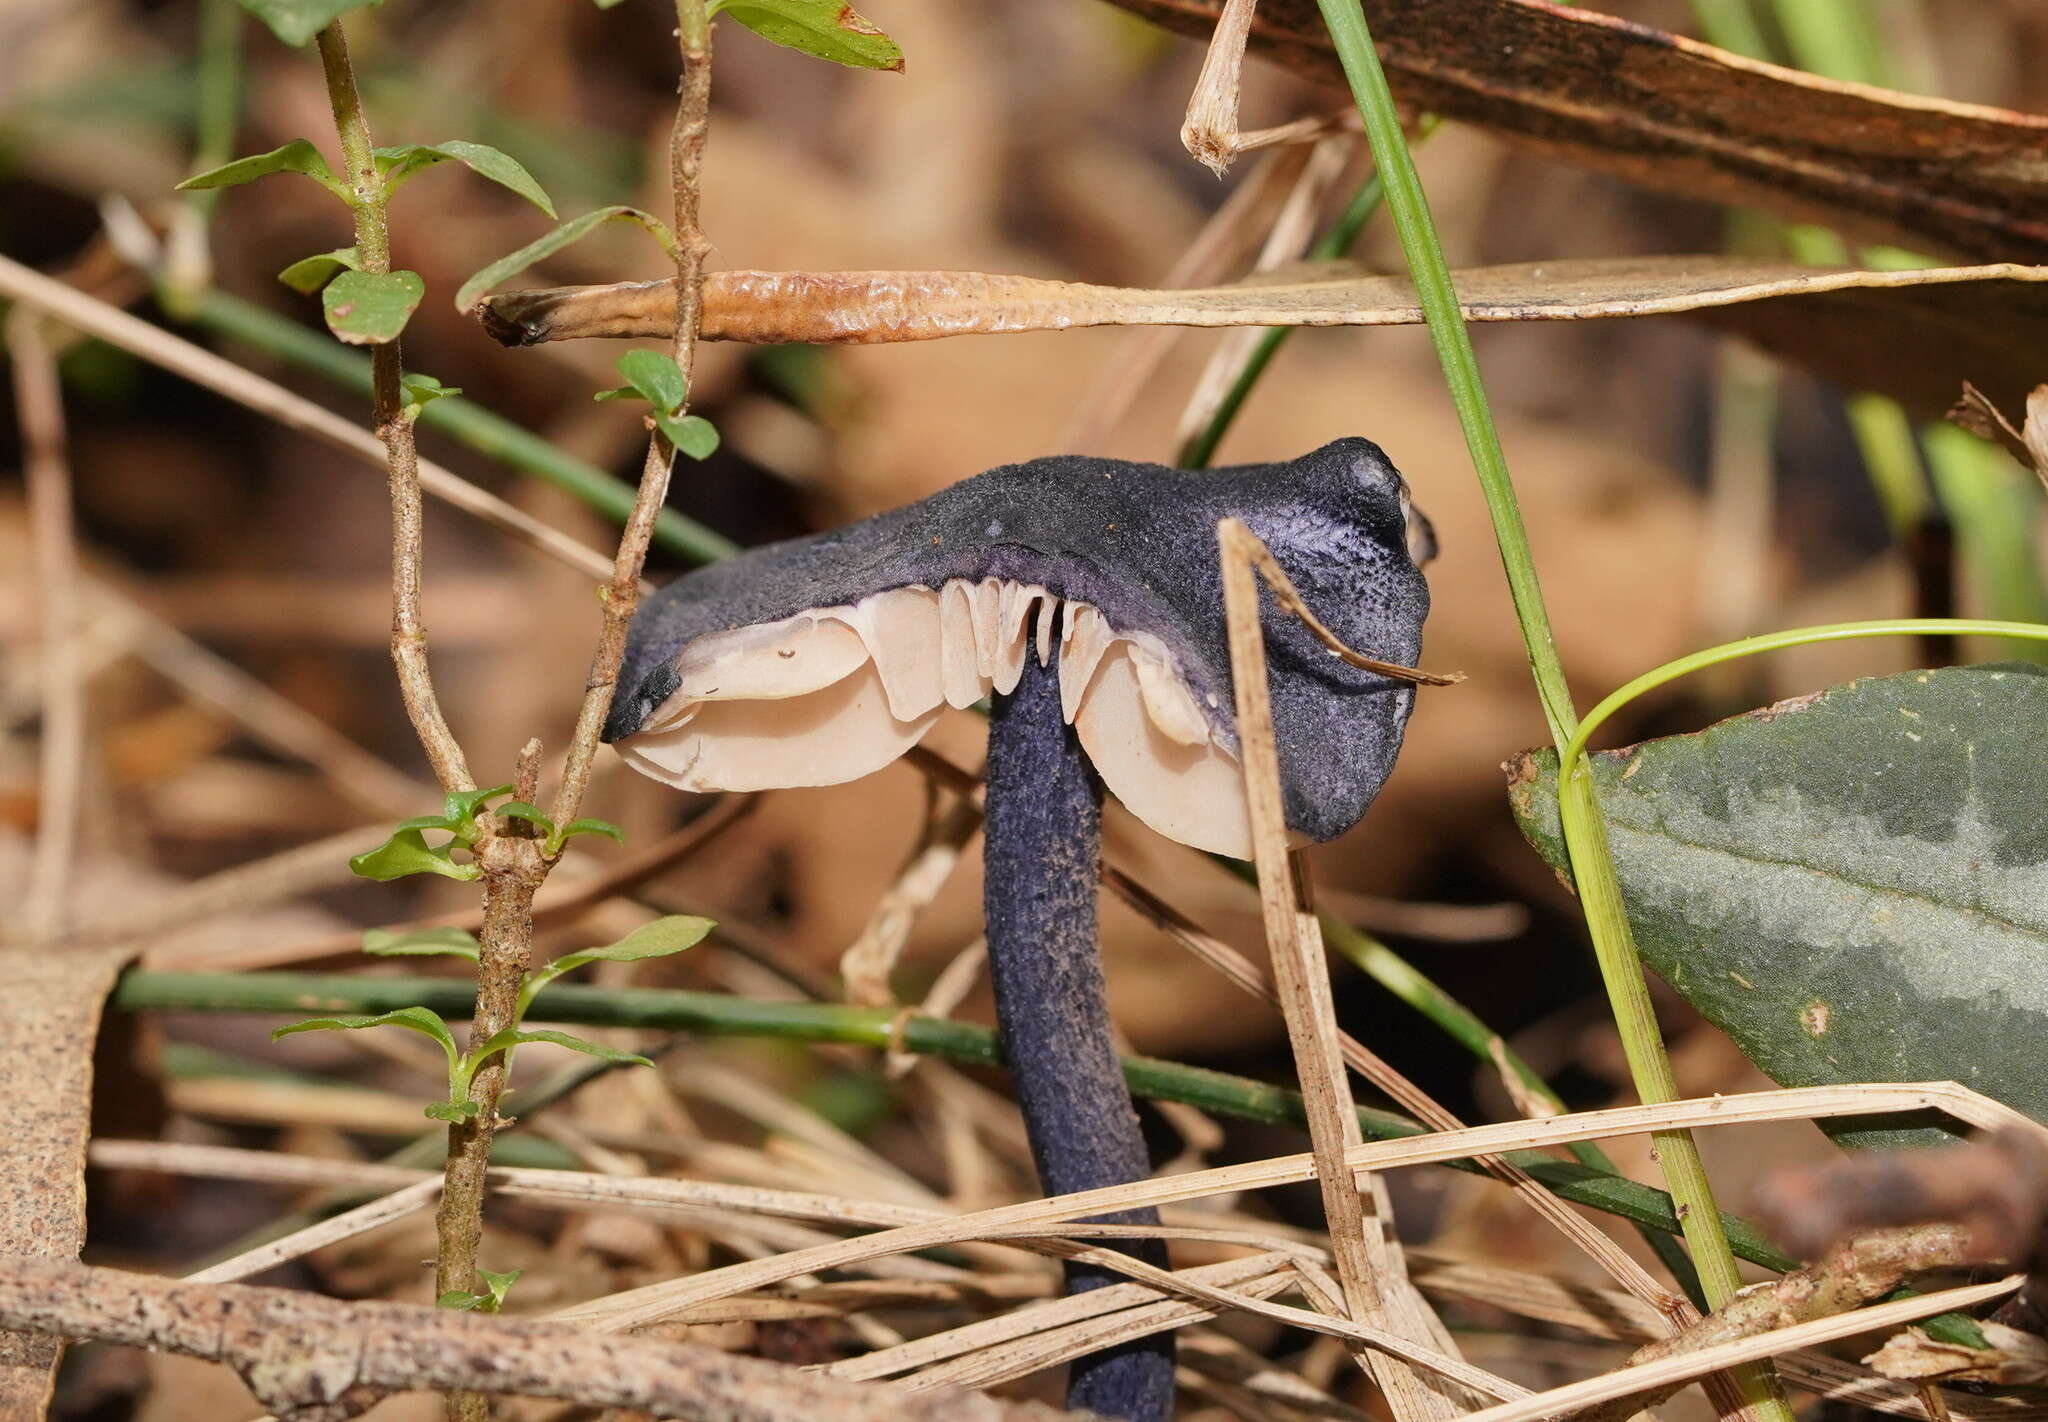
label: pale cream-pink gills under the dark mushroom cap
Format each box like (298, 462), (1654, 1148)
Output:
(618, 578), (1251, 859)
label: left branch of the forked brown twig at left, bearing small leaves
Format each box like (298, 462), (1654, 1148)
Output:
(317, 20), (475, 791)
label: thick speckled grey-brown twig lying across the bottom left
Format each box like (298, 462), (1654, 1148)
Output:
(0, 1258), (1097, 1422)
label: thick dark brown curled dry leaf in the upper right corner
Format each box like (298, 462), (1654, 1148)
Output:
(1114, 0), (2048, 262)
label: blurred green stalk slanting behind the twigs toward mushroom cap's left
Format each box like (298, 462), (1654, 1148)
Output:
(178, 291), (739, 563)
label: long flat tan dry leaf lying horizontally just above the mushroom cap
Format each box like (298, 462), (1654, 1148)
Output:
(483, 256), (2048, 416)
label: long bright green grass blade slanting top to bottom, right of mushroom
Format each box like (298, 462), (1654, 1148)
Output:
(1317, 0), (1792, 1422)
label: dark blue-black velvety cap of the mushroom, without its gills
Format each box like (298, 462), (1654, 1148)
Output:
(604, 438), (1430, 848)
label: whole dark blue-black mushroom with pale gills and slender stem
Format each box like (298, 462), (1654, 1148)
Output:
(606, 438), (1430, 1420)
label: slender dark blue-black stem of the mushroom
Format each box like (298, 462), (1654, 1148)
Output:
(983, 639), (1174, 1422)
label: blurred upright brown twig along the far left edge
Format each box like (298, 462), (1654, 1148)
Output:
(6, 311), (86, 940)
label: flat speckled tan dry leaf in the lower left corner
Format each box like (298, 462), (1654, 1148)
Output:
(0, 947), (133, 1418)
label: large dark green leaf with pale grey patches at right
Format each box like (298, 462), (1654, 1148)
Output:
(1509, 664), (2048, 1145)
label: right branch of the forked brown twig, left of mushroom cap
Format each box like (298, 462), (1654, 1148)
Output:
(553, 0), (711, 824)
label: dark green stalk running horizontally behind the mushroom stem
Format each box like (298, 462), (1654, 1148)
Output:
(113, 971), (1798, 1270)
